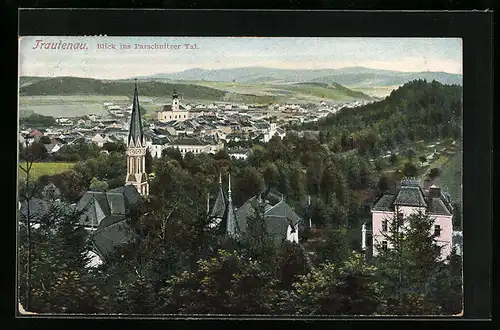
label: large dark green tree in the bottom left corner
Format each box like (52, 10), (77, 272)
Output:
(19, 203), (102, 313)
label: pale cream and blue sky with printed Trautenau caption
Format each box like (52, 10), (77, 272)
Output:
(19, 36), (462, 79)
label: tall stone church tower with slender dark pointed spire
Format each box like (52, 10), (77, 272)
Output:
(125, 79), (149, 196)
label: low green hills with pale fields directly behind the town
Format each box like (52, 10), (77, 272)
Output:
(20, 77), (370, 104)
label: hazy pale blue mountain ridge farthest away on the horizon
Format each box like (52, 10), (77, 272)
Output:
(139, 67), (462, 86)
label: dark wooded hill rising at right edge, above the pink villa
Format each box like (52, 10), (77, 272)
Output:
(296, 80), (462, 154)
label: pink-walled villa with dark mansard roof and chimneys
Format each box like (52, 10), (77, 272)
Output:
(362, 179), (453, 259)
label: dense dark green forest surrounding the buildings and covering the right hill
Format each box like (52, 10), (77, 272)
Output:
(19, 81), (462, 315)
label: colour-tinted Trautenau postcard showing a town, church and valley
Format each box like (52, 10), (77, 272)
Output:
(17, 36), (463, 317)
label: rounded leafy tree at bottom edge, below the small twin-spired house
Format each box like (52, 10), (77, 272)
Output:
(160, 250), (277, 314)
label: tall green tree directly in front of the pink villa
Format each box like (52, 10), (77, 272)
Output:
(374, 212), (441, 315)
